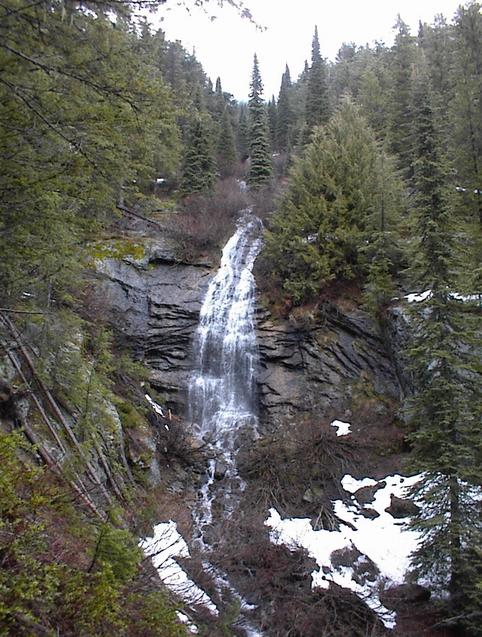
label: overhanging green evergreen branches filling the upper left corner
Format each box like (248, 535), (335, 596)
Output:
(0, 0), (178, 304)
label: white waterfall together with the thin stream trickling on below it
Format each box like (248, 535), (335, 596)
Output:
(189, 211), (262, 637)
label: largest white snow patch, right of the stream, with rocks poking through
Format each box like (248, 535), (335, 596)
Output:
(265, 475), (420, 628)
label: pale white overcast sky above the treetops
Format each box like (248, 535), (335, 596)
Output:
(149, 0), (461, 100)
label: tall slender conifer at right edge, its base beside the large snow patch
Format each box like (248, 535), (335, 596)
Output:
(409, 67), (482, 634)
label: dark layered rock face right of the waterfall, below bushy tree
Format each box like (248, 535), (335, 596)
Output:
(258, 304), (400, 422)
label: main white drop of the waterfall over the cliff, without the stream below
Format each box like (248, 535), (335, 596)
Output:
(189, 214), (262, 438)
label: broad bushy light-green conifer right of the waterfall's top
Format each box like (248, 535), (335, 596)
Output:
(265, 99), (400, 302)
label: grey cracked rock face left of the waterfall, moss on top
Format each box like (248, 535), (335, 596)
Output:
(97, 236), (212, 413)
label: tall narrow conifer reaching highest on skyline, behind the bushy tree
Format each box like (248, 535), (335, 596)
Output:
(304, 27), (330, 142)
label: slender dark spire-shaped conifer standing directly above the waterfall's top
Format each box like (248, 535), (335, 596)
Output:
(248, 54), (272, 187)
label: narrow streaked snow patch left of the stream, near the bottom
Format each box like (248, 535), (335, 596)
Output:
(139, 520), (218, 615)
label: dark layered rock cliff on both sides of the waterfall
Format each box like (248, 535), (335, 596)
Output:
(97, 241), (401, 429)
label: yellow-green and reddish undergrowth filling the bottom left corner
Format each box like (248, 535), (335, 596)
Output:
(0, 432), (186, 637)
